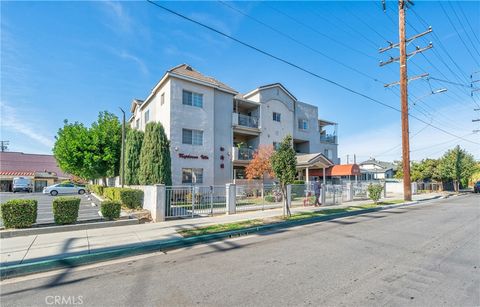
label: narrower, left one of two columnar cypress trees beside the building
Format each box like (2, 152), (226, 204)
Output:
(125, 129), (144, 185)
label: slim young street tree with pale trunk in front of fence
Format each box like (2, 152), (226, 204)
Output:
(270, 135), (297, 216)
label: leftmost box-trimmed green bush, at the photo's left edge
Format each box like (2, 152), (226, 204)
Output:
(0, 199), (37, 228)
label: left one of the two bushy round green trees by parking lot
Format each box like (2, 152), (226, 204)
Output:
(53, 120), (93, 179)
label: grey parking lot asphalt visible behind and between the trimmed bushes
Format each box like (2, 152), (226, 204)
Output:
(0, 192), (100, 224)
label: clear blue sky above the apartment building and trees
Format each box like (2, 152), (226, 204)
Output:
(1, 0), (480, 162)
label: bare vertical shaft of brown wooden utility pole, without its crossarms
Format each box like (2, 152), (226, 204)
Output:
(398, 0), (412, 200)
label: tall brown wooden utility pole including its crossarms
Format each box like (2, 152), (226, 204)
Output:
(379, 0), (433, 201)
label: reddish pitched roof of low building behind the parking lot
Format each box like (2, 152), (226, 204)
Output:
(0, 152), (70, 178)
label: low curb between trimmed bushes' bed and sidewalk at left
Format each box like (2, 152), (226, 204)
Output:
(0, 218), (139, 239)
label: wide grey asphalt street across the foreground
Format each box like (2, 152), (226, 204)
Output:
(1, 194), (480, 306)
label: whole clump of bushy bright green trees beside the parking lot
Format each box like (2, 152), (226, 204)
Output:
(53, 111), (121, 184)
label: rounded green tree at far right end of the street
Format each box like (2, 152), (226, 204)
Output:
(438, 145), (476, 191)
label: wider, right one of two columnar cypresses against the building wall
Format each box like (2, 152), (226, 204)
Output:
(139, 122), (172, 185)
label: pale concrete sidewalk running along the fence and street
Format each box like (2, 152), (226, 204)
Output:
(0, 193), (443, 267)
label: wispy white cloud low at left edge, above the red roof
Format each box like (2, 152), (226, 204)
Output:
(0, 101), (54, 149)
